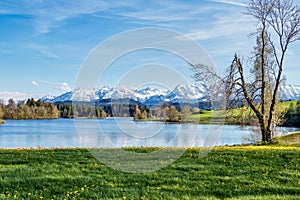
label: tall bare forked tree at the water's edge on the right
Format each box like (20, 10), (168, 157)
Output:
(191, 0), (300, 142)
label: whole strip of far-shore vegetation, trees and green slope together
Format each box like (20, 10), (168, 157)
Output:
(0, 99), (300, 130)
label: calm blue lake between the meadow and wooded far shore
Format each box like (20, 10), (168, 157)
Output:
(0, 118), (300, 148)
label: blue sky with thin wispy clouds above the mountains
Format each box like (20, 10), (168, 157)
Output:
(0, 0), (300, 98)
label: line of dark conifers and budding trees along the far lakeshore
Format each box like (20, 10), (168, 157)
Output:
(0, 98), (300, 127)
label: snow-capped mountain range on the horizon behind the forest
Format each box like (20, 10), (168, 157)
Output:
(42, 83), (300, 105)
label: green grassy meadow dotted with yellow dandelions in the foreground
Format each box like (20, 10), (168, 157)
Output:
(0, 145), (300, 199)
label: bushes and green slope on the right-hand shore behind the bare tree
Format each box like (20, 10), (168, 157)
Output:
(134, 101), (300, 127)
